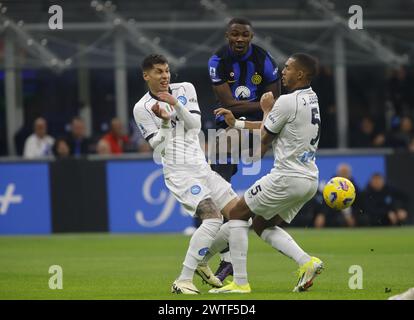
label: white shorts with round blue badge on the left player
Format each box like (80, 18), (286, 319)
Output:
(165, 167), (237, 216)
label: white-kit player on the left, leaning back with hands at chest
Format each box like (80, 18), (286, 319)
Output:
(134, 54), (238, 294)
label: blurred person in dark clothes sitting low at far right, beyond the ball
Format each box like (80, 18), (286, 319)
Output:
(363, 173), (408, 226)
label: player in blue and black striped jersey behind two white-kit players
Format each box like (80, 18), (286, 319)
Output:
(208, 18), (281, 280)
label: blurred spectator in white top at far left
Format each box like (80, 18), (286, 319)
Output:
(23, 118), (55, 159)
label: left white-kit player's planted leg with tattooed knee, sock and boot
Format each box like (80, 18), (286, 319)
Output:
(171, 198), (222, 294)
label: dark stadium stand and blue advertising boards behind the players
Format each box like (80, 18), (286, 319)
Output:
(0, 0), (414, 298)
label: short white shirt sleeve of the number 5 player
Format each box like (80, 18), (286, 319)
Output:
(264, 96), (296, 134)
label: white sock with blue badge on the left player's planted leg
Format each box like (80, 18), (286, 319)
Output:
(178, 219), (223, 280)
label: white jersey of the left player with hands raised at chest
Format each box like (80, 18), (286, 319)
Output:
(134, 82), (208, 178)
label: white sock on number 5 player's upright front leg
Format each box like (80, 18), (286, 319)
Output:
(229, 220), (249, 285)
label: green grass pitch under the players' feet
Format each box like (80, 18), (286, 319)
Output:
(0, 227), (414, 300)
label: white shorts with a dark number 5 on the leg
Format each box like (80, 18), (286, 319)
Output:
(244, 173), (318, 223)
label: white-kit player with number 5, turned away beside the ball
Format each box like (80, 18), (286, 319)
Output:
(210, 53), (323, 293)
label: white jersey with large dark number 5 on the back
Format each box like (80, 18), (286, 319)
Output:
(264, 86), (321, 179)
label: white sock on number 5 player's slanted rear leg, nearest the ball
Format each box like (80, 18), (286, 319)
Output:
(261, 227), (311, 266)
